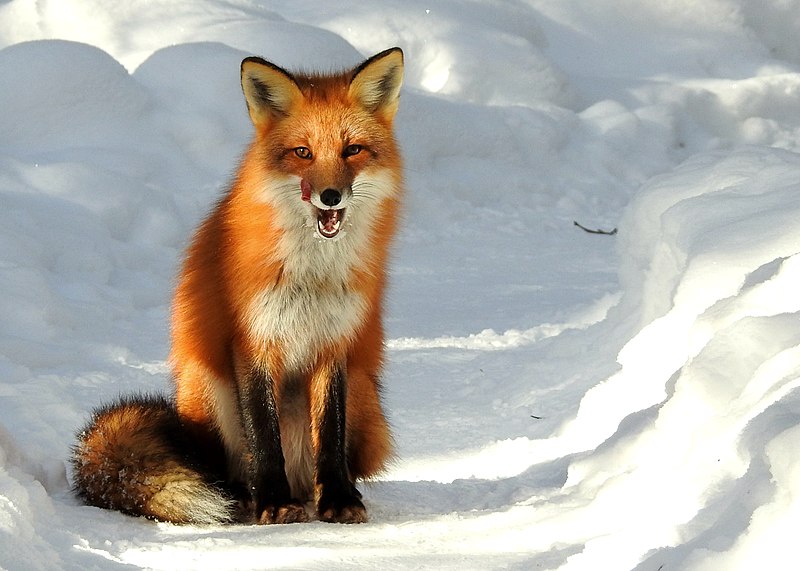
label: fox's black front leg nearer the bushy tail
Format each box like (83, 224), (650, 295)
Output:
(239, 367), (308, 524)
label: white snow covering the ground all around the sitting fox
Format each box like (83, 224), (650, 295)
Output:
(0, 0), (800, 571)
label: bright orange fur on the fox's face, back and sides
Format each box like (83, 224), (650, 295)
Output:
(171, 48), (401, 510)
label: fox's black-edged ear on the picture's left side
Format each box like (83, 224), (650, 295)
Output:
(242, 57), (303, 125)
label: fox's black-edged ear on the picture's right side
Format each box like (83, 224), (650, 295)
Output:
(350, 48), (403, 120)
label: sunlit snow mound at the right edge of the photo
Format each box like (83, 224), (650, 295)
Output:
(561, 149), (800, 569)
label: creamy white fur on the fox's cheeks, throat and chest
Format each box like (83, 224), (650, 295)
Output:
(241, 171), (399, 371)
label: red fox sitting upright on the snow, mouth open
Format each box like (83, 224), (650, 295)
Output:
(72, 48), (403, 524)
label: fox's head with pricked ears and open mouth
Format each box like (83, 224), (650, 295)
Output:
(236, 48), (403, 240)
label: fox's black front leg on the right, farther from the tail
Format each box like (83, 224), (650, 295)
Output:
(311, 365), (367, 523)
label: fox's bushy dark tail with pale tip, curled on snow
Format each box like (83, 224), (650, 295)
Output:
(72, 396), (238, 524)
